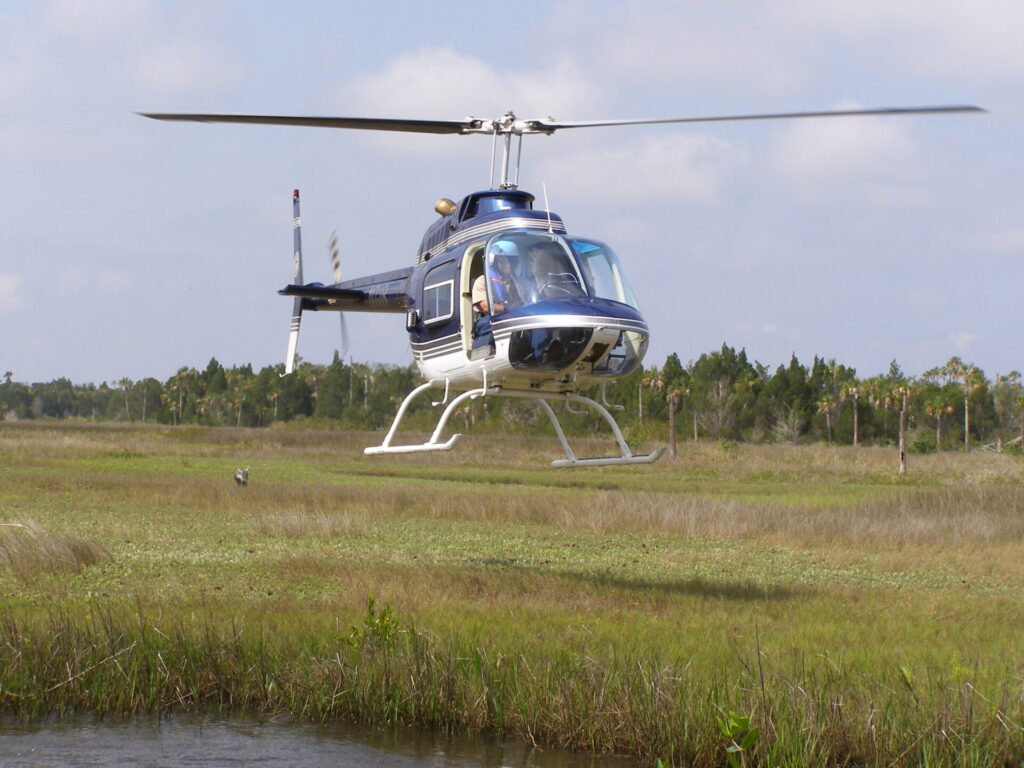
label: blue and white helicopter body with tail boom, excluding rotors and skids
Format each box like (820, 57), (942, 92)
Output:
(282, 189), (649, 392)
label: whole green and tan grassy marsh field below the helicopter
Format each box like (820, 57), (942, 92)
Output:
(0, 423), (1024, 766)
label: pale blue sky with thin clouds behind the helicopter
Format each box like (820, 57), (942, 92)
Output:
(0, 0), (1024, 383)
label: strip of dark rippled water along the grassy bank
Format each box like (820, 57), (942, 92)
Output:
(0, 716), (639, 768)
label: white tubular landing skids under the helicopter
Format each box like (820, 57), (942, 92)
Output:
(362, 379), (665, 467)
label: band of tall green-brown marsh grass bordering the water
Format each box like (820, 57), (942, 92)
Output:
(0, 608), (1024, 766)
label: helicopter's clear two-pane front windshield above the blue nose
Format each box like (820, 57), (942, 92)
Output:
(486, 232), (637, 311)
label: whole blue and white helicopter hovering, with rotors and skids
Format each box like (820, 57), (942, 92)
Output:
(138, 104), (984, 467)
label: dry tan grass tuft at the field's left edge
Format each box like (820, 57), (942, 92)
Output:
(0, 522), (110, 581)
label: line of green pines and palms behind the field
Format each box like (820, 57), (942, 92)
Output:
(6, 344), (1024, 452)
